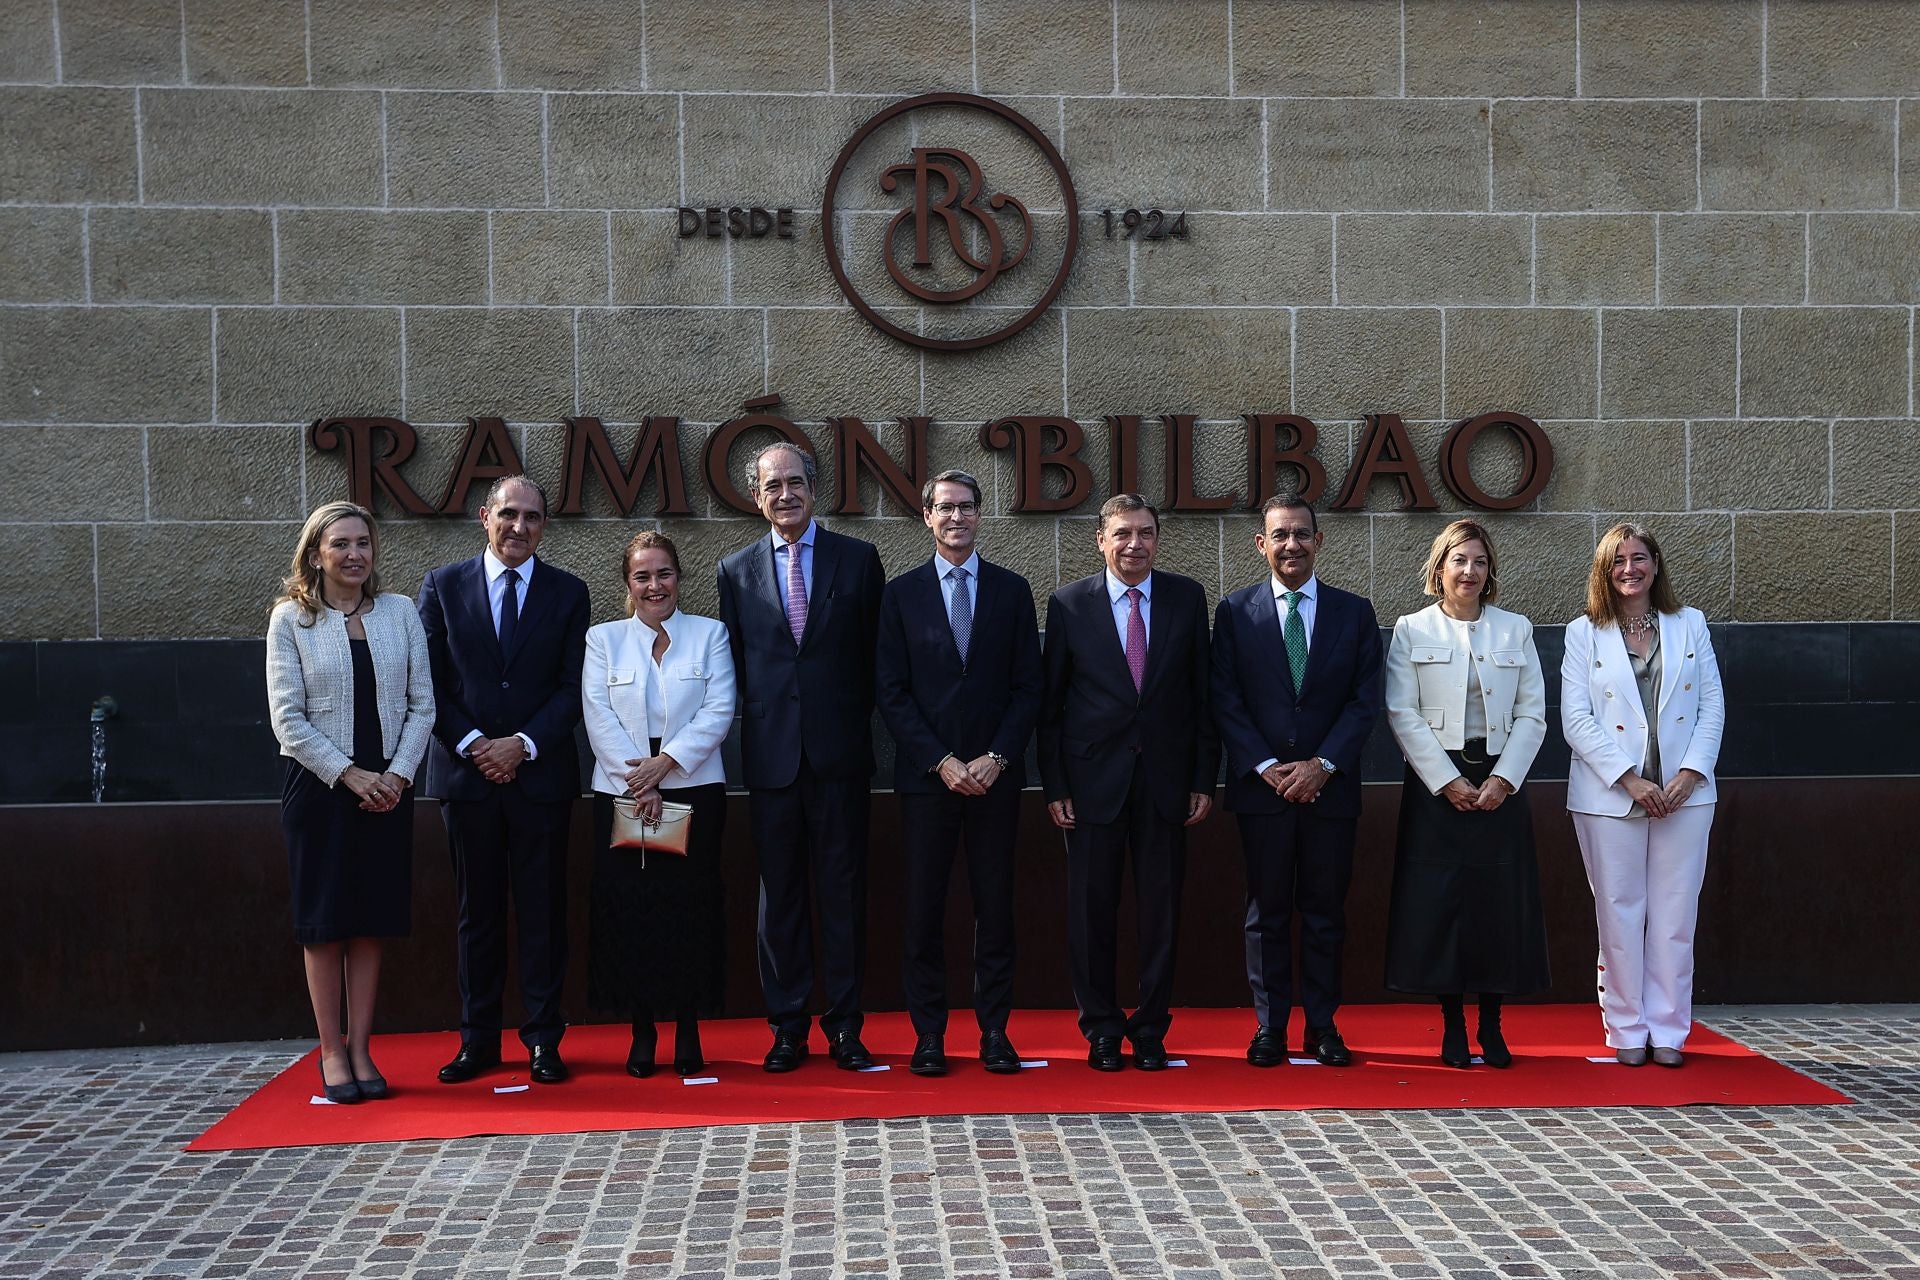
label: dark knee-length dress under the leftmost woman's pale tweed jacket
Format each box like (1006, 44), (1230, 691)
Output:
(280, 639), (413, 944)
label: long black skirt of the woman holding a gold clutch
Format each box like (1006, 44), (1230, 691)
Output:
(588, 771), (726, 1017)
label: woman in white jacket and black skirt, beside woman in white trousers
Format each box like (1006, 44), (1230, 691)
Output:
(1386, 520), (1548, 1067)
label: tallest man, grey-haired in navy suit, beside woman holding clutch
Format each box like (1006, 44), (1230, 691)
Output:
(720, 443), (887, 1071)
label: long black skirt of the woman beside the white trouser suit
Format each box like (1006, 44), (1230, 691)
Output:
(1386, 752), (1551, 996)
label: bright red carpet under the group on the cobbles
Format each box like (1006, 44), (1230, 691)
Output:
(188, 1006), (1849, 1151)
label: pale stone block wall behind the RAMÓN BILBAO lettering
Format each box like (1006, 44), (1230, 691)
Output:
(0, 0), (1920, 639)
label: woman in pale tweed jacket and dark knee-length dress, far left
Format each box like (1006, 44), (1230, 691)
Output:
(267, 503), (434, 1102)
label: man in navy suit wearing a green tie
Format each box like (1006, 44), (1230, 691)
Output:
(1213, 495), (1380, 1067)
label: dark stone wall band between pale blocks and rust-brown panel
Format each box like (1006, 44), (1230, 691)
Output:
(11, 622), (1920, 805)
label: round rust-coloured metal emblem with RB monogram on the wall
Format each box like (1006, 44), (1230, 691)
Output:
(820, 94), (1079, 351)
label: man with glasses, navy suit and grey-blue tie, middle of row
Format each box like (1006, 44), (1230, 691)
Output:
(874, 470), (1041, 1075)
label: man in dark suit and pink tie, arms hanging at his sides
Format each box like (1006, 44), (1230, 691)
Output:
(1041, 493), (1219, 1071)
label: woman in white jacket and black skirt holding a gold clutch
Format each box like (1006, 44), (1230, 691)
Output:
(580, 530), (733, 1079)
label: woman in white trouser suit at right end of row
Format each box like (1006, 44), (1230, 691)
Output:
(1561, 524), (1726, 1067)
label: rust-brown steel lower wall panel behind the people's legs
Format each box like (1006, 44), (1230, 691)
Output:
(0, 777), (1920, 1050)
